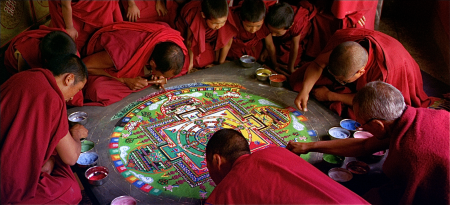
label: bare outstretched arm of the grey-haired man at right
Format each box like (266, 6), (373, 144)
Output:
(286, 137), (390, 157)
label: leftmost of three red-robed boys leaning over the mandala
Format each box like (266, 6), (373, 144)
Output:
(176, 0), (237, 71)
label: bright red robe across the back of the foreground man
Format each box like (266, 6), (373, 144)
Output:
(206, 147), (368, 204)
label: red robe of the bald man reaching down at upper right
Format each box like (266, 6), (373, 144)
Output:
(289, 28), (432, 119)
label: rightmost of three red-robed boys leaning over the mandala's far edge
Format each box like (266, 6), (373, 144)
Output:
(266, 1), (315, 74)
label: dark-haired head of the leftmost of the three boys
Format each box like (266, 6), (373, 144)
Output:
(201, 0), (228, 30)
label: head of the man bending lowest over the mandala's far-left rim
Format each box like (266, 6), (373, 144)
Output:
(150, 41), (184, 78)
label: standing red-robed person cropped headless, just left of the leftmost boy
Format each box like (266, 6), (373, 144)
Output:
(121, 0), (185, 28)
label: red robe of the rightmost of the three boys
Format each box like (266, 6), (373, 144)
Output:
(273, 1), (316, 65)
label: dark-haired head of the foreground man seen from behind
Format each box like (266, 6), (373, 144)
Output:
(205, 129), (250, 184)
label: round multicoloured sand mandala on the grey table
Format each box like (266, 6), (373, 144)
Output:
(109, 82), (316, 199)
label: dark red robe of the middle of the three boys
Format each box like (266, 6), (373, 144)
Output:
(227, 6), (270, 60)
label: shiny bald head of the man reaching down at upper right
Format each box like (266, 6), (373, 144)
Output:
(328, 41), (369, 84)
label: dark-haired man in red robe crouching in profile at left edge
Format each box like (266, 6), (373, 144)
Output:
(0, 54), (88, 204)
